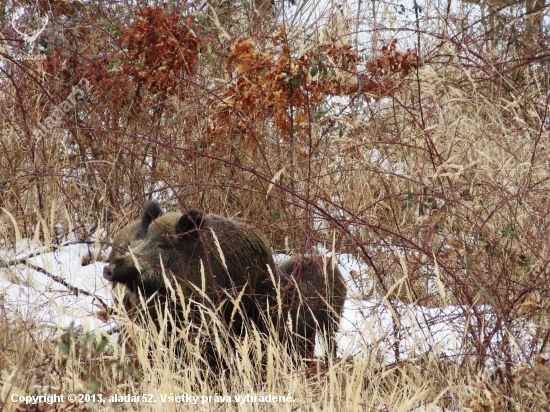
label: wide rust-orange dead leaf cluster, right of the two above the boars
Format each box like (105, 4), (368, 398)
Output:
(209, 26), (419, 138)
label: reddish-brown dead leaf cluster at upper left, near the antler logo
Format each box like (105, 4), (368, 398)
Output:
(39, 7), (201, 115)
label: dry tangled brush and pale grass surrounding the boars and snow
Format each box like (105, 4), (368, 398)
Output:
(0, 1), (550, 411)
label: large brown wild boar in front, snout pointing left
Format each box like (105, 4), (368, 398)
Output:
(104, 210), (275, 342)
